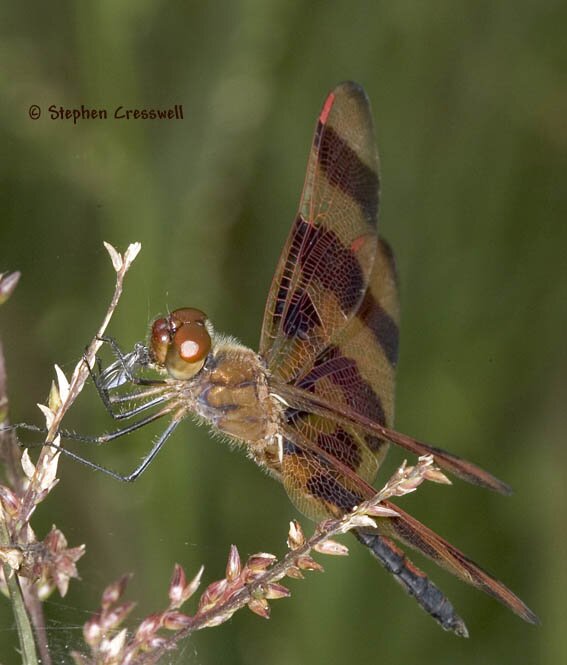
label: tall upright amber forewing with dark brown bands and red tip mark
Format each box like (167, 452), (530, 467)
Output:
(260, 82), (379, 382)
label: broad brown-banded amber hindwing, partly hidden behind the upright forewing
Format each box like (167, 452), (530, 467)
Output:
(275, 239), (399, 519)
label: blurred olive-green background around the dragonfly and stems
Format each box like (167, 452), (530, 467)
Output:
(0, 0), (567, 665)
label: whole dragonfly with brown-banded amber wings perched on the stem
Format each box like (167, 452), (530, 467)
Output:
(81, 82), (537, 635)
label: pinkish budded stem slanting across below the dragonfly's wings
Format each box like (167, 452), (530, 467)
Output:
(72, 456), (447, 665)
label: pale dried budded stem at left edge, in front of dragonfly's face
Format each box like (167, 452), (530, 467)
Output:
(0, 243), (140, 665)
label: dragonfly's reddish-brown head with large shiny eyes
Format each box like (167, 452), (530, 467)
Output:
(148, 307), (211, 379)
